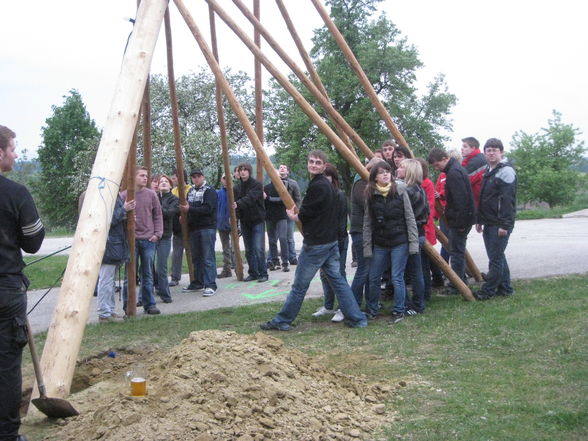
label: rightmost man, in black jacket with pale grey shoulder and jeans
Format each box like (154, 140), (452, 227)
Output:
(475, 138), (517, 300)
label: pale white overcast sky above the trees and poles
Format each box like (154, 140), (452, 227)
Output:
(0, 0), (588, 158)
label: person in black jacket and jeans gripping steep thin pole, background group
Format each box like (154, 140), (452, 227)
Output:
(233, 162), (268, 282)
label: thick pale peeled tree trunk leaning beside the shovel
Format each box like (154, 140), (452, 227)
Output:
(36, 0), (167, 398)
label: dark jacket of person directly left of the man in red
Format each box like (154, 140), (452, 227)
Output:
(443, 158), (476, 229)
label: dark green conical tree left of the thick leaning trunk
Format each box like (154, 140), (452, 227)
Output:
(33, 89), (100, 228)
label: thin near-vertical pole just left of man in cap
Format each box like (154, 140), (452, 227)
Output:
(163, 4), (194, 282)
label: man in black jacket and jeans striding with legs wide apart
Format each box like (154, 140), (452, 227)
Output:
(260, 150), (367, 331)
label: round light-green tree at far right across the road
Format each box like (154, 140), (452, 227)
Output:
(508, 110), (585, 207)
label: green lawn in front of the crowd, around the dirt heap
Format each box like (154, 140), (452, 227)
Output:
(25, 274), (588, 441)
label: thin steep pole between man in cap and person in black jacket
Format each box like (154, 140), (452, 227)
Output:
(208, 5), (243, 280)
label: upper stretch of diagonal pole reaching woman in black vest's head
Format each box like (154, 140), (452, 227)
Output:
(202, 0), (373, 179)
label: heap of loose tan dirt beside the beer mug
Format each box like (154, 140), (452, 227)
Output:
(54, 331), (392, 441)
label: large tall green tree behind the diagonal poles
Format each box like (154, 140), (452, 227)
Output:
(265, 0), (456, 188)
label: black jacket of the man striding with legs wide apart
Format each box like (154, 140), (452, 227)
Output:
(298, 175), (338, 245)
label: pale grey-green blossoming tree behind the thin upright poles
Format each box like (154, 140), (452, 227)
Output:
(138, 68), (255, 186)
